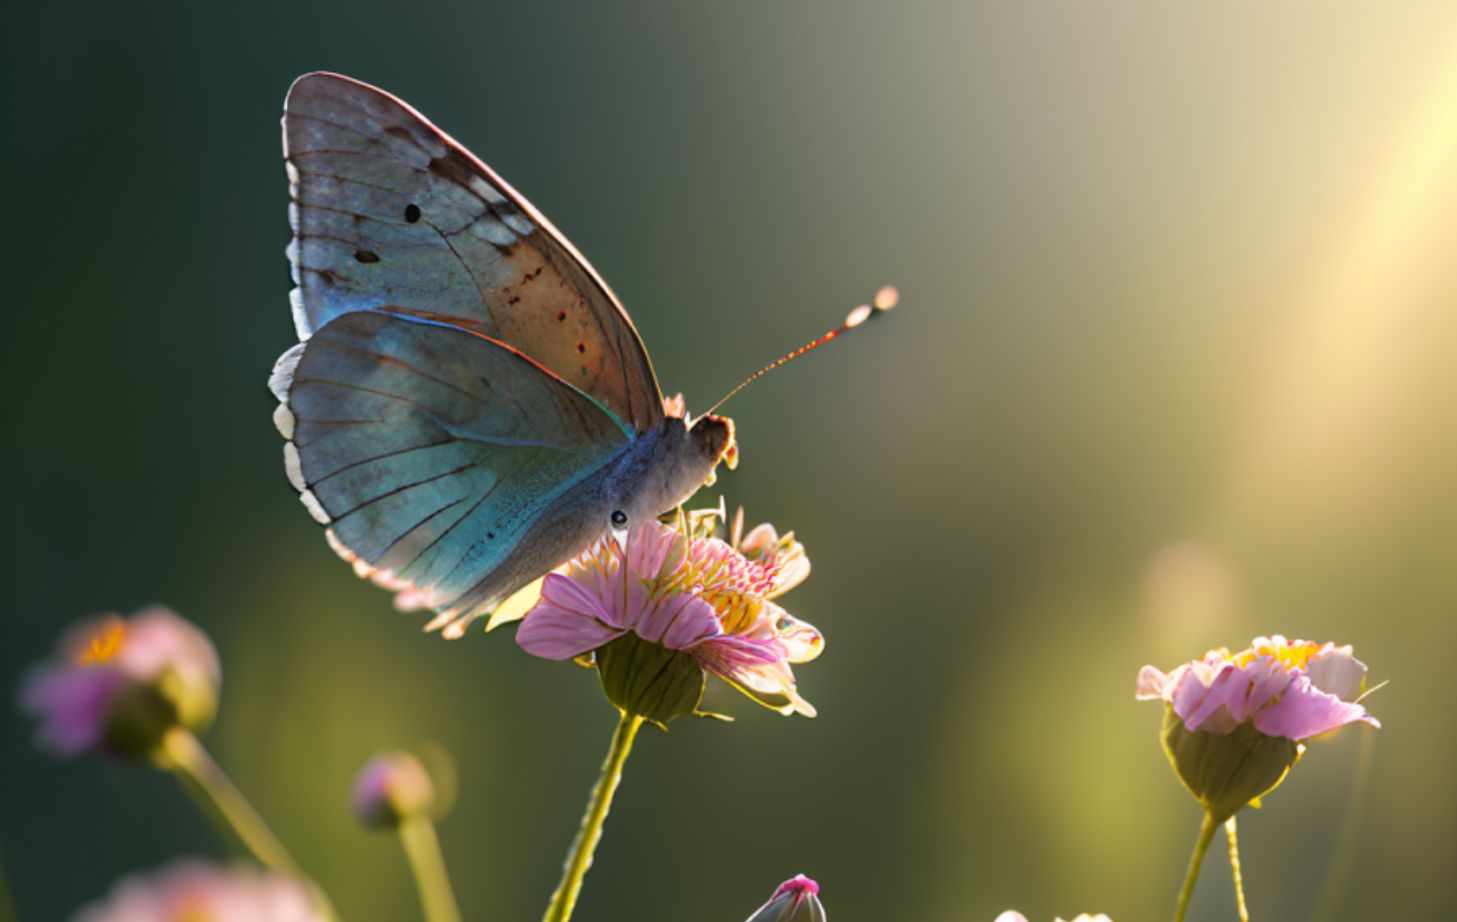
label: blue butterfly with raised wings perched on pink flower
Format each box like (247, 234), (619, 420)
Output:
(270, 73), (891, 637)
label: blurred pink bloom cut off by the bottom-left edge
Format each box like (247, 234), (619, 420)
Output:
(71, 859), (326, 922)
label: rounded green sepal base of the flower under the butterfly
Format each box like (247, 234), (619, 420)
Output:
(596, 634), (708, 730)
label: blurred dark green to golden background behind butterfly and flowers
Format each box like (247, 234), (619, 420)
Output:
(0, 0), (1457, 922)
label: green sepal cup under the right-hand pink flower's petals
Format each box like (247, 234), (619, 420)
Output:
(1161, 706), (1304, 823)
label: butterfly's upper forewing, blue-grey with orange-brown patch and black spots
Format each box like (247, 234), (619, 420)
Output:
(283, 73), (663, 433)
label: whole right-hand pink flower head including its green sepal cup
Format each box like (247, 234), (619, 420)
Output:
(1136, 634), (1381, 823)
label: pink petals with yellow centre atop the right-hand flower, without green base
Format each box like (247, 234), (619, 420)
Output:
(1136, 634), (1381, 741)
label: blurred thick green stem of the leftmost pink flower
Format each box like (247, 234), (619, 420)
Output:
(159, 727), (338, 919)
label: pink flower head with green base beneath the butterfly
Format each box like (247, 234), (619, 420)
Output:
(516, 513), (825, 724)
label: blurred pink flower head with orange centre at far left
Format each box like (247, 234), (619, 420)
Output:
(20, 606), (221, 757)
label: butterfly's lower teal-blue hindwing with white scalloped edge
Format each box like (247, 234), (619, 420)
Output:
(270, 310), (632, 632)
